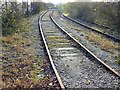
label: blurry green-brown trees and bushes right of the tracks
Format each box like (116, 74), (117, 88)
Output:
(59, 2), (120, 32)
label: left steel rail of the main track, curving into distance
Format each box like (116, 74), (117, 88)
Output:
(38, 11), (65, 90)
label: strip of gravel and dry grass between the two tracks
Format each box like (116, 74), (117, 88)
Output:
(53, 11), (120, 73)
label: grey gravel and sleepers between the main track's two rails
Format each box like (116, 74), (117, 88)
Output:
(42, 12), (119, 90)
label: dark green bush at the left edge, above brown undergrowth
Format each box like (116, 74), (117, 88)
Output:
(2, 10), (19, 35)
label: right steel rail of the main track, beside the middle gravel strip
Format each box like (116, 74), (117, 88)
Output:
(49, 11), (120, 77)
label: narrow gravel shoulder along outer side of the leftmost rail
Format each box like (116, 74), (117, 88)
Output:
(31, 14), (60, 89)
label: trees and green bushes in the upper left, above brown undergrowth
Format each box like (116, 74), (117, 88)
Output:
(2, 1), (48, 35)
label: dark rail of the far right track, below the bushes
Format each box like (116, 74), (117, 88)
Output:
(61, 13), (120, 42)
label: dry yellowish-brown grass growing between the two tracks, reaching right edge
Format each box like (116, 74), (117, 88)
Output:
(62, 14), (120, 63)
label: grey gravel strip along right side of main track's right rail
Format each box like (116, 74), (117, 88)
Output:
(53, 12), (120, 73)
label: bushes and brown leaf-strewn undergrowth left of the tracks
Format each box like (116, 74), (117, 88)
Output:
(0, 2), (55, 90)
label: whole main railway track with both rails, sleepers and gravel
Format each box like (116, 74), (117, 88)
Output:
(38, 11), (120, 89)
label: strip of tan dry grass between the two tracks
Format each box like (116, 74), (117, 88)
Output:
(66, 19), (120, 52)
